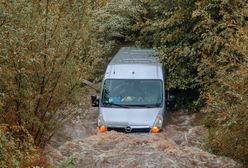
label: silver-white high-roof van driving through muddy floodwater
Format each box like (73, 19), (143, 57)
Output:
(92, 47), (174, 133)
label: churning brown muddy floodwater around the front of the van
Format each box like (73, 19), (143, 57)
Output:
(46, 108), (241, 168)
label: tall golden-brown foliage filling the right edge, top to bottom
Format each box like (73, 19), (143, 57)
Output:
(190, 0), (248, 165)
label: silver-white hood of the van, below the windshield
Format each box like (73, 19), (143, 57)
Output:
(100, 107), (162, 128)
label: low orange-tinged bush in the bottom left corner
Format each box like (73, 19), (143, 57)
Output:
(0, 125), (39, 168)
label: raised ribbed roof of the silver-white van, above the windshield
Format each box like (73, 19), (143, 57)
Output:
(105, 47), (163, 80)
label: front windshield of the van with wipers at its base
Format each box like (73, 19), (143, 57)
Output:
(102, 79), (163, 108)
